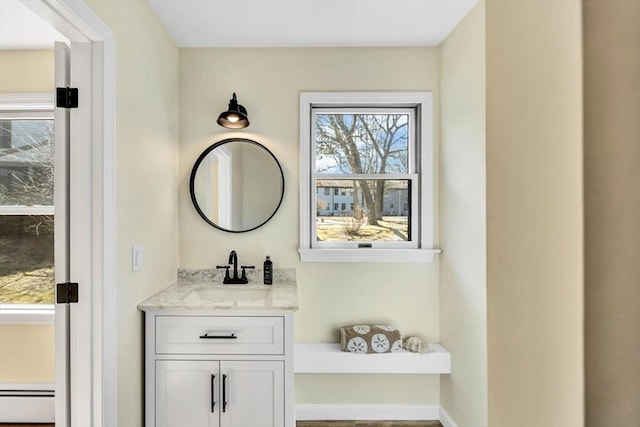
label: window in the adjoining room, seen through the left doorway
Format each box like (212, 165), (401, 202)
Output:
(0, 95), (54, 311)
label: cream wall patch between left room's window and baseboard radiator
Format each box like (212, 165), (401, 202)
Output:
(0, 325), (55, 383)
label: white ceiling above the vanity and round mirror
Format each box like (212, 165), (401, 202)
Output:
(148, 0), (478, 47)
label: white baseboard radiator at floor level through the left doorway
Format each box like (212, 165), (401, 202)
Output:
(0, 383), (55, 423)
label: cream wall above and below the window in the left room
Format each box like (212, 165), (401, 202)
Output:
(0, 50), (55, 383)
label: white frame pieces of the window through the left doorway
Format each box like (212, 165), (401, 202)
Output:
(0, 93), (55, 325)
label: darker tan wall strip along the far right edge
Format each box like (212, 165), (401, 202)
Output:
(583, 0), (640, 427)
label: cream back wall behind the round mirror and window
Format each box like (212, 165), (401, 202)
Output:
(179, 48), (440, 404)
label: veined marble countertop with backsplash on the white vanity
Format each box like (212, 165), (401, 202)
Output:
(138, 269), (298, 311)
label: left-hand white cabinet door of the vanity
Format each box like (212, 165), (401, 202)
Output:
(155, 360), (222, 427)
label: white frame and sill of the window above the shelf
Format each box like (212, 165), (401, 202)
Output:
(298, 92), (440, 263)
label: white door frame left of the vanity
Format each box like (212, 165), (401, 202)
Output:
(21, 0), (117, 426)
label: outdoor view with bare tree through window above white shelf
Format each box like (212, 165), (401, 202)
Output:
(314, 109), (417, 242)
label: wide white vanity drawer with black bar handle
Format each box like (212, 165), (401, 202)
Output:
(155, 316), (284, 354)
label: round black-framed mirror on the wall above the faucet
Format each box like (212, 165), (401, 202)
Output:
(189, 138), (284, 233)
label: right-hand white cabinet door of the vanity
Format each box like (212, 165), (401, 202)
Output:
(220, 361), (284, 427)
